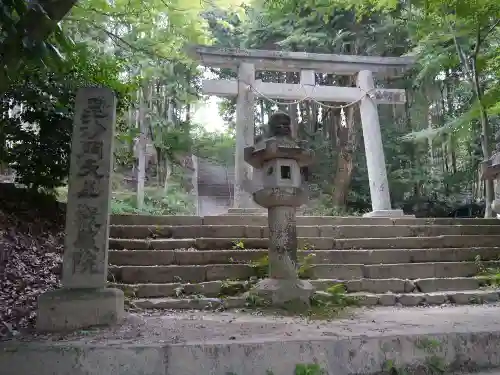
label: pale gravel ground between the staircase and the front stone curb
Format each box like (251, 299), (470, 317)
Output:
(8, 304), (500, 345)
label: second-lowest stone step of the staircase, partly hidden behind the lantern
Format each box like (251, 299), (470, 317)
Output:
(112, 277), (486, 298)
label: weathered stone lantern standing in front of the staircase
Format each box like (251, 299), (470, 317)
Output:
(245, 112), (314, 307)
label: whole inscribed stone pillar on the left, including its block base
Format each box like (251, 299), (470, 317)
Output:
(37, 88), (124, 331)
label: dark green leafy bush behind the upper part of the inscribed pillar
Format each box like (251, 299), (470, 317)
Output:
(0, 45), (132, 190)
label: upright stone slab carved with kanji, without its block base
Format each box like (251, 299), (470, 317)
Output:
(63, 88), (116, 288)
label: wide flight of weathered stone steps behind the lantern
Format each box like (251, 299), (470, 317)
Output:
(109, 215), (500, 309)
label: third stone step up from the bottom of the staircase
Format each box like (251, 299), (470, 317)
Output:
(109, 262), (498, 284)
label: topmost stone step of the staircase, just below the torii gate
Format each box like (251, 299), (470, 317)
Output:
(110, 215), (500, 226)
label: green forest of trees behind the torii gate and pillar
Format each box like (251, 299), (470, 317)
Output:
(0, 0), (500, 216)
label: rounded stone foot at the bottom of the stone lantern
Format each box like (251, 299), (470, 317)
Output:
(251, 279), (314, 310)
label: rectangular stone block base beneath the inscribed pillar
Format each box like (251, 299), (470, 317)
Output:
(36, 288), (125, 332)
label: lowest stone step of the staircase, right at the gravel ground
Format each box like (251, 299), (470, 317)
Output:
(134, 290), (499, 310)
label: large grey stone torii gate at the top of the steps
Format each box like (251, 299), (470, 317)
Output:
(191, 46), (414, 217)
